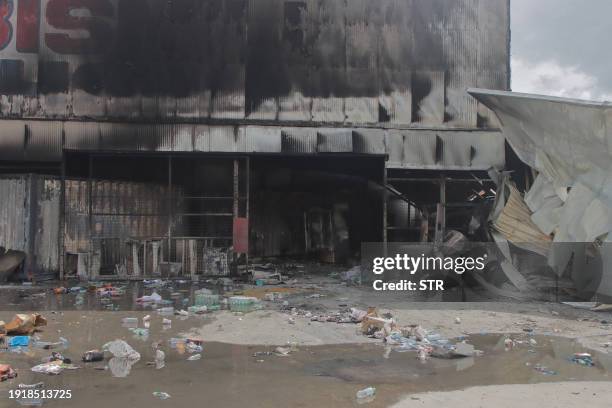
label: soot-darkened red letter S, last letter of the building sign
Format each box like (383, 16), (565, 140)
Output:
(46, 0), (113, 54)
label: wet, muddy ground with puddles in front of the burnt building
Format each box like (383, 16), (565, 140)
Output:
(0, 277), (612, 407)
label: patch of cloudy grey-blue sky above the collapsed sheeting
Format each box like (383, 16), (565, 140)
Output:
(511, 0), (612, 101)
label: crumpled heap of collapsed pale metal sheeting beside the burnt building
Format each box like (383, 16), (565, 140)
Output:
(469, 89), (612, 299)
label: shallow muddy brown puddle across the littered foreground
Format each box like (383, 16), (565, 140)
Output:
(0, 311), (612, 408)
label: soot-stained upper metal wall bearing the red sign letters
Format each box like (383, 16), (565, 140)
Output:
(0, 0), (509, 127)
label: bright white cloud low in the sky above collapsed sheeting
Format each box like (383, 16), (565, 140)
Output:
(512, 57), (612, 101)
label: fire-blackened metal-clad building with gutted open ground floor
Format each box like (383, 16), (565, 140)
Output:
(0, 0), (510, 279)
